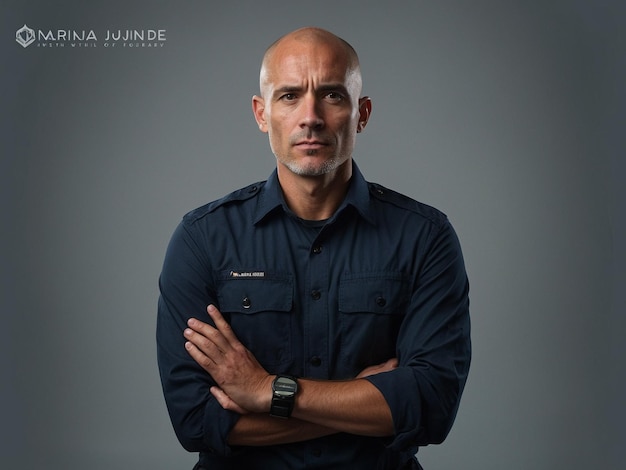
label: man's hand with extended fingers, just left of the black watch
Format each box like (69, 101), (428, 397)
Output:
(184, 305), (273, 414)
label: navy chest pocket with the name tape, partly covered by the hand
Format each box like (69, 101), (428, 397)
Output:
(217, 271), (294, 373)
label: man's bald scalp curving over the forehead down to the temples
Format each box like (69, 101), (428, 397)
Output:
(259, 27), (361, 97)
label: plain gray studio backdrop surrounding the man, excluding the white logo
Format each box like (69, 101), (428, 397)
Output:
(0, 0), (626, 470)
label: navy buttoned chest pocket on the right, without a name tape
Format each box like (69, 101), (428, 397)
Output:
(339, 272), (411, 373)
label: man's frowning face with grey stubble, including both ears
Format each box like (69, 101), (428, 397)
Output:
(253, 36), (371, 176)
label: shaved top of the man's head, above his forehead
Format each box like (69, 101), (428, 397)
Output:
(259, 27), (361, 96)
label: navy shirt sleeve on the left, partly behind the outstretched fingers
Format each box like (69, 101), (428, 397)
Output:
(156, 220), (238, 455)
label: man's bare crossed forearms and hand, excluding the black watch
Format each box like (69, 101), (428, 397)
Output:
(184, 305), (397, 446)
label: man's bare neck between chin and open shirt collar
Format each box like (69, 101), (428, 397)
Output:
(277, 159), (352, 220)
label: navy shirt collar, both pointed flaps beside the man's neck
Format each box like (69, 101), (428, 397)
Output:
(254, 160), (374, 225)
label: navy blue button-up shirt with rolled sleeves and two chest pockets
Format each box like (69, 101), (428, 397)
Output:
(157, 164), (470, 469)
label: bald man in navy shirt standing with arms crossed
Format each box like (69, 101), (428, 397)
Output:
(157, 28), (470, 469)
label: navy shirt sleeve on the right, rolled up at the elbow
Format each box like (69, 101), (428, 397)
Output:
(367, 219), (471, 451)
